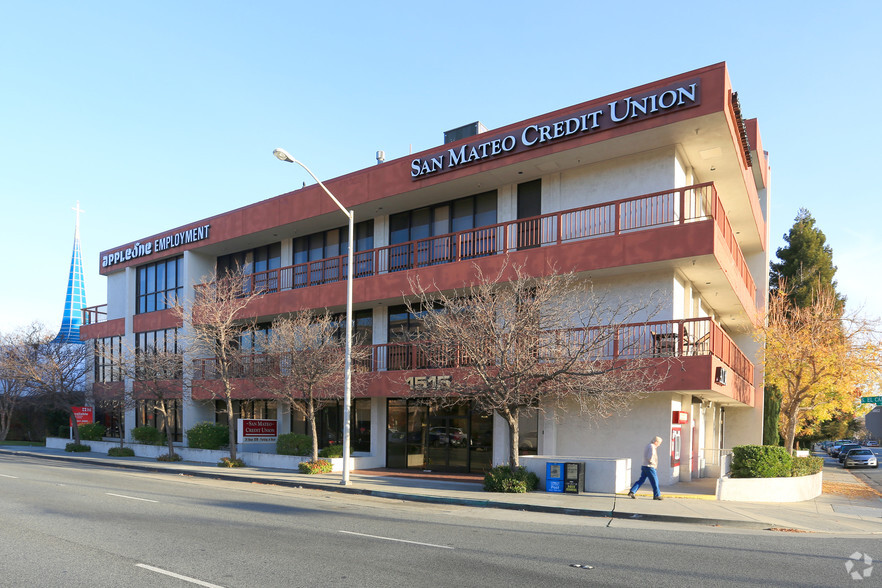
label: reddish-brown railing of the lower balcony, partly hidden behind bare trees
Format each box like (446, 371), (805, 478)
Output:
(193, 318), (753, 383)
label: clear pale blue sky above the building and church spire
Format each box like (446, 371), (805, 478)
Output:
(0, 0), (882, 333)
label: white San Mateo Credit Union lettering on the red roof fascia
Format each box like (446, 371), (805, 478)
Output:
(410, 80), (701, 180)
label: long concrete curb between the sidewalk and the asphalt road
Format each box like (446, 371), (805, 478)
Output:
(0, 449), (775, 530)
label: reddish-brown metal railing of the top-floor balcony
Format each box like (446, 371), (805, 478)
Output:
(229, 183), (756, 296)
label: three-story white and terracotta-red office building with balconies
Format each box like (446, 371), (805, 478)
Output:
(81, 64), (770, 484)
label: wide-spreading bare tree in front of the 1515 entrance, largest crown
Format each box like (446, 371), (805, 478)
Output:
(408, 260), (667, 467)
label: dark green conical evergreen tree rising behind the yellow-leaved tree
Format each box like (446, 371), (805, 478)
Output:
(769, 208), (845, 311)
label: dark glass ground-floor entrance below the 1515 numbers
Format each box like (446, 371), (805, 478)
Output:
(386, 398), (493, 473)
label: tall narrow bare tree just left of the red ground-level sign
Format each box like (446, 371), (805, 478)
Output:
(174, 268), (262, 460)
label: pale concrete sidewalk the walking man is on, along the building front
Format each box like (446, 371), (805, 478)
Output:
(0, 446), (882, 535)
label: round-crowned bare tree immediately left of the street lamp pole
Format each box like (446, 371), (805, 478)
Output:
(257, 311), (367, 461)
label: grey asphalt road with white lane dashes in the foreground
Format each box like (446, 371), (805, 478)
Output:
(0, 455), (882, 588)
